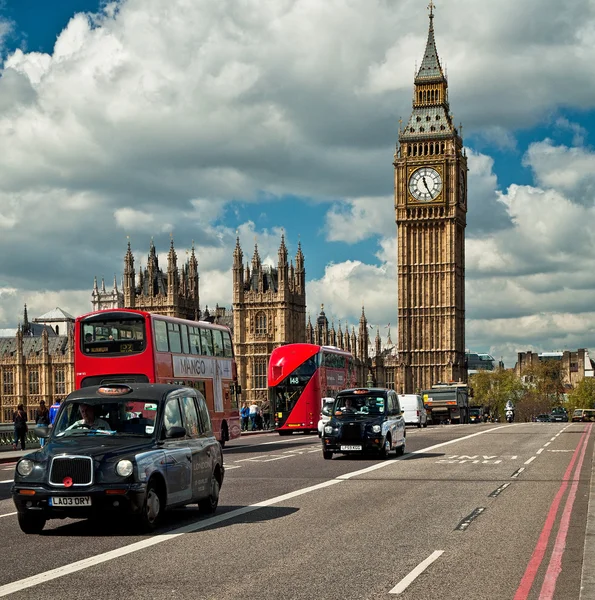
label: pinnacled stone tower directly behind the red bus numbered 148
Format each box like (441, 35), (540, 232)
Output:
(233, 236), (306, 402)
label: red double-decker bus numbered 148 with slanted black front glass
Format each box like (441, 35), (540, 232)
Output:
(268, 344), (357, 435)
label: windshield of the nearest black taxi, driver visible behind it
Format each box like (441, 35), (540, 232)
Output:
(53, 398), (157, 437)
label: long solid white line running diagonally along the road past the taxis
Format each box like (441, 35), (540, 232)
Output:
(0, 425), (511, 597)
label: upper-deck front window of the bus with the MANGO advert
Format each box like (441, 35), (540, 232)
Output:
(80, 313), (146, 356)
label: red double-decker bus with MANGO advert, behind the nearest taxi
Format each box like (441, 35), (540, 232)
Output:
(74, 308), (241, 445)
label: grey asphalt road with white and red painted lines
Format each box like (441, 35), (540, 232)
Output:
(0, 423), (593, 600)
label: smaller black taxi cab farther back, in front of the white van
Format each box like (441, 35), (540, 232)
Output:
(322, 388), (406, 459)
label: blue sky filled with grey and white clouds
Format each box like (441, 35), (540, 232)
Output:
(0, 0), (595, 366)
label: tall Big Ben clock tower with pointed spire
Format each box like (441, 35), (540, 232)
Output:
(394, 1), (467, 393)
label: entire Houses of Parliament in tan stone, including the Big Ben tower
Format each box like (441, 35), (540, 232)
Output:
(0, 9), (580, 422)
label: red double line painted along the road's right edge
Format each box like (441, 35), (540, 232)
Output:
(514, 425), (593, 600)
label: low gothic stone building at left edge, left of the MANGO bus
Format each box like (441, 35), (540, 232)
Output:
(0, 306), (74, 423)
